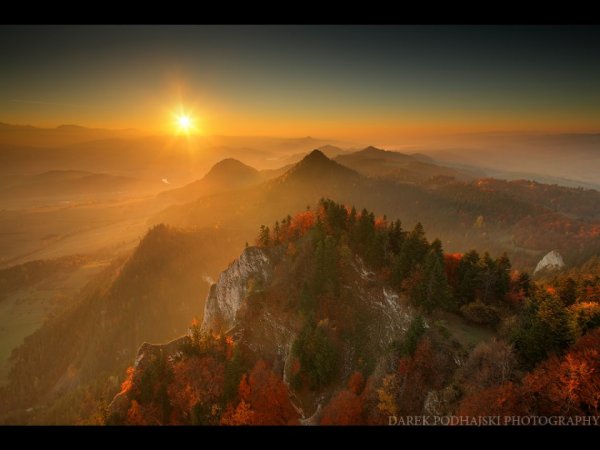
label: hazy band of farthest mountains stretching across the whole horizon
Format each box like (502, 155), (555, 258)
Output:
(0, 123), (600, 188)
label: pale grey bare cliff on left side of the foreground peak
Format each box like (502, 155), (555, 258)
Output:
(202, 247), (272, 331)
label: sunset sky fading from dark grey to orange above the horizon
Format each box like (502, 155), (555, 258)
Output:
(0, 26), (600, 143)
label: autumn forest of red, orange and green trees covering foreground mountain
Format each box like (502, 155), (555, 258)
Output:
(107, 200), (600, 425)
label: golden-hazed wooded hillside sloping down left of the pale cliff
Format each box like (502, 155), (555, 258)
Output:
(0, 225), (243, 422)
